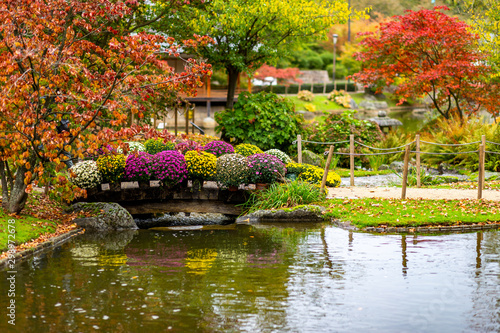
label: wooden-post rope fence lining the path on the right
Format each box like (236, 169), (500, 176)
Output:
(293, 134), (490, 199)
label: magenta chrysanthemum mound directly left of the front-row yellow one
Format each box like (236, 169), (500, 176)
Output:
(149, 150), (188, 187)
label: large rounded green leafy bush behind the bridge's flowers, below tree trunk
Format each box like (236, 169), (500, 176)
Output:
(215, 92), (303, 151)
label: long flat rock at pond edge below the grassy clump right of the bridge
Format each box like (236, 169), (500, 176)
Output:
(236, 205), (325, 224)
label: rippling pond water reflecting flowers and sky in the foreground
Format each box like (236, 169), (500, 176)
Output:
(0, 224), (500, 332)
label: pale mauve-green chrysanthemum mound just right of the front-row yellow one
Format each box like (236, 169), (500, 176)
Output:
(215, 154), (250, 188)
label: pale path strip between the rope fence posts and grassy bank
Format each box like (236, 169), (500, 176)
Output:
(328, 186), (500, 201)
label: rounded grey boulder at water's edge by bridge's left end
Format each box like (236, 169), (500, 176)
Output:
(68, 202), (137, 231)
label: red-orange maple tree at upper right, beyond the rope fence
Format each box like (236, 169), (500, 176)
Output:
(352, 6), (498, 121)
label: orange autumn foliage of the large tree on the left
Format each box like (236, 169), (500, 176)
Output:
(0, 0), (211, 212)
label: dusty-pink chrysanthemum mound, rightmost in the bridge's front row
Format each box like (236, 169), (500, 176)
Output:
(247, 153), (286, 183)
